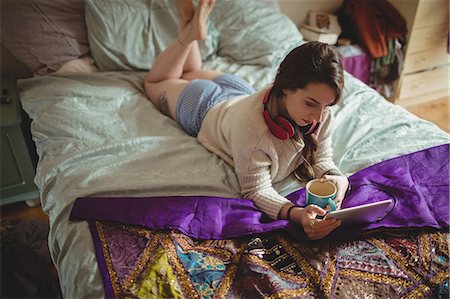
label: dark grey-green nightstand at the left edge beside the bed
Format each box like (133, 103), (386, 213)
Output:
(0, 76), (39, 206)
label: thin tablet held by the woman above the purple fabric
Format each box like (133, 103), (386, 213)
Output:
(324, 199), (392, 224)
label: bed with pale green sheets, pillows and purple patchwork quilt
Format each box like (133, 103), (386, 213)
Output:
(2, 0), (450, 298)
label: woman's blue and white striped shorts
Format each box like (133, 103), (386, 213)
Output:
(176, 74), (255, 136)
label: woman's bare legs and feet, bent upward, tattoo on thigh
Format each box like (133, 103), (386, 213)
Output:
(145, 0), (220, 120)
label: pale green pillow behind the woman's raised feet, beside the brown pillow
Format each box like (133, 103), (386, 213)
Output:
(85, 0), (217, 71)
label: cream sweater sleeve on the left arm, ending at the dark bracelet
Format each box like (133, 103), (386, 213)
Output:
(237, 150), (290, 219)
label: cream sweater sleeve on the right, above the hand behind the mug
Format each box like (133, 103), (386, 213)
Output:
(313, 109), (340, 178)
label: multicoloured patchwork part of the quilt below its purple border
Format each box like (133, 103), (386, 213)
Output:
(90, 221), (449, 298)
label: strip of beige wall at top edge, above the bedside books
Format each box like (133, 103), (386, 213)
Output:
(278, 0), (344, 26)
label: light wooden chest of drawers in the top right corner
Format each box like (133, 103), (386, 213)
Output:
(390, 0), (450, 106)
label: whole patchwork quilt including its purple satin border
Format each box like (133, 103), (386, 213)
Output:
(71, 144), (450, 298)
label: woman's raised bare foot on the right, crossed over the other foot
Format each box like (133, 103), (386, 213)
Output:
(178, 0), (215, 45)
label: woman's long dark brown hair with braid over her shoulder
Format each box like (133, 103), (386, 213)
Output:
(271, 42), (344, 181)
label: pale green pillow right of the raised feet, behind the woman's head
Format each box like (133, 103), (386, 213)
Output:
(211, 0), (303, 67)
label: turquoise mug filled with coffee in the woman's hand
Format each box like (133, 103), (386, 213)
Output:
(306, 179), (337, 211)
